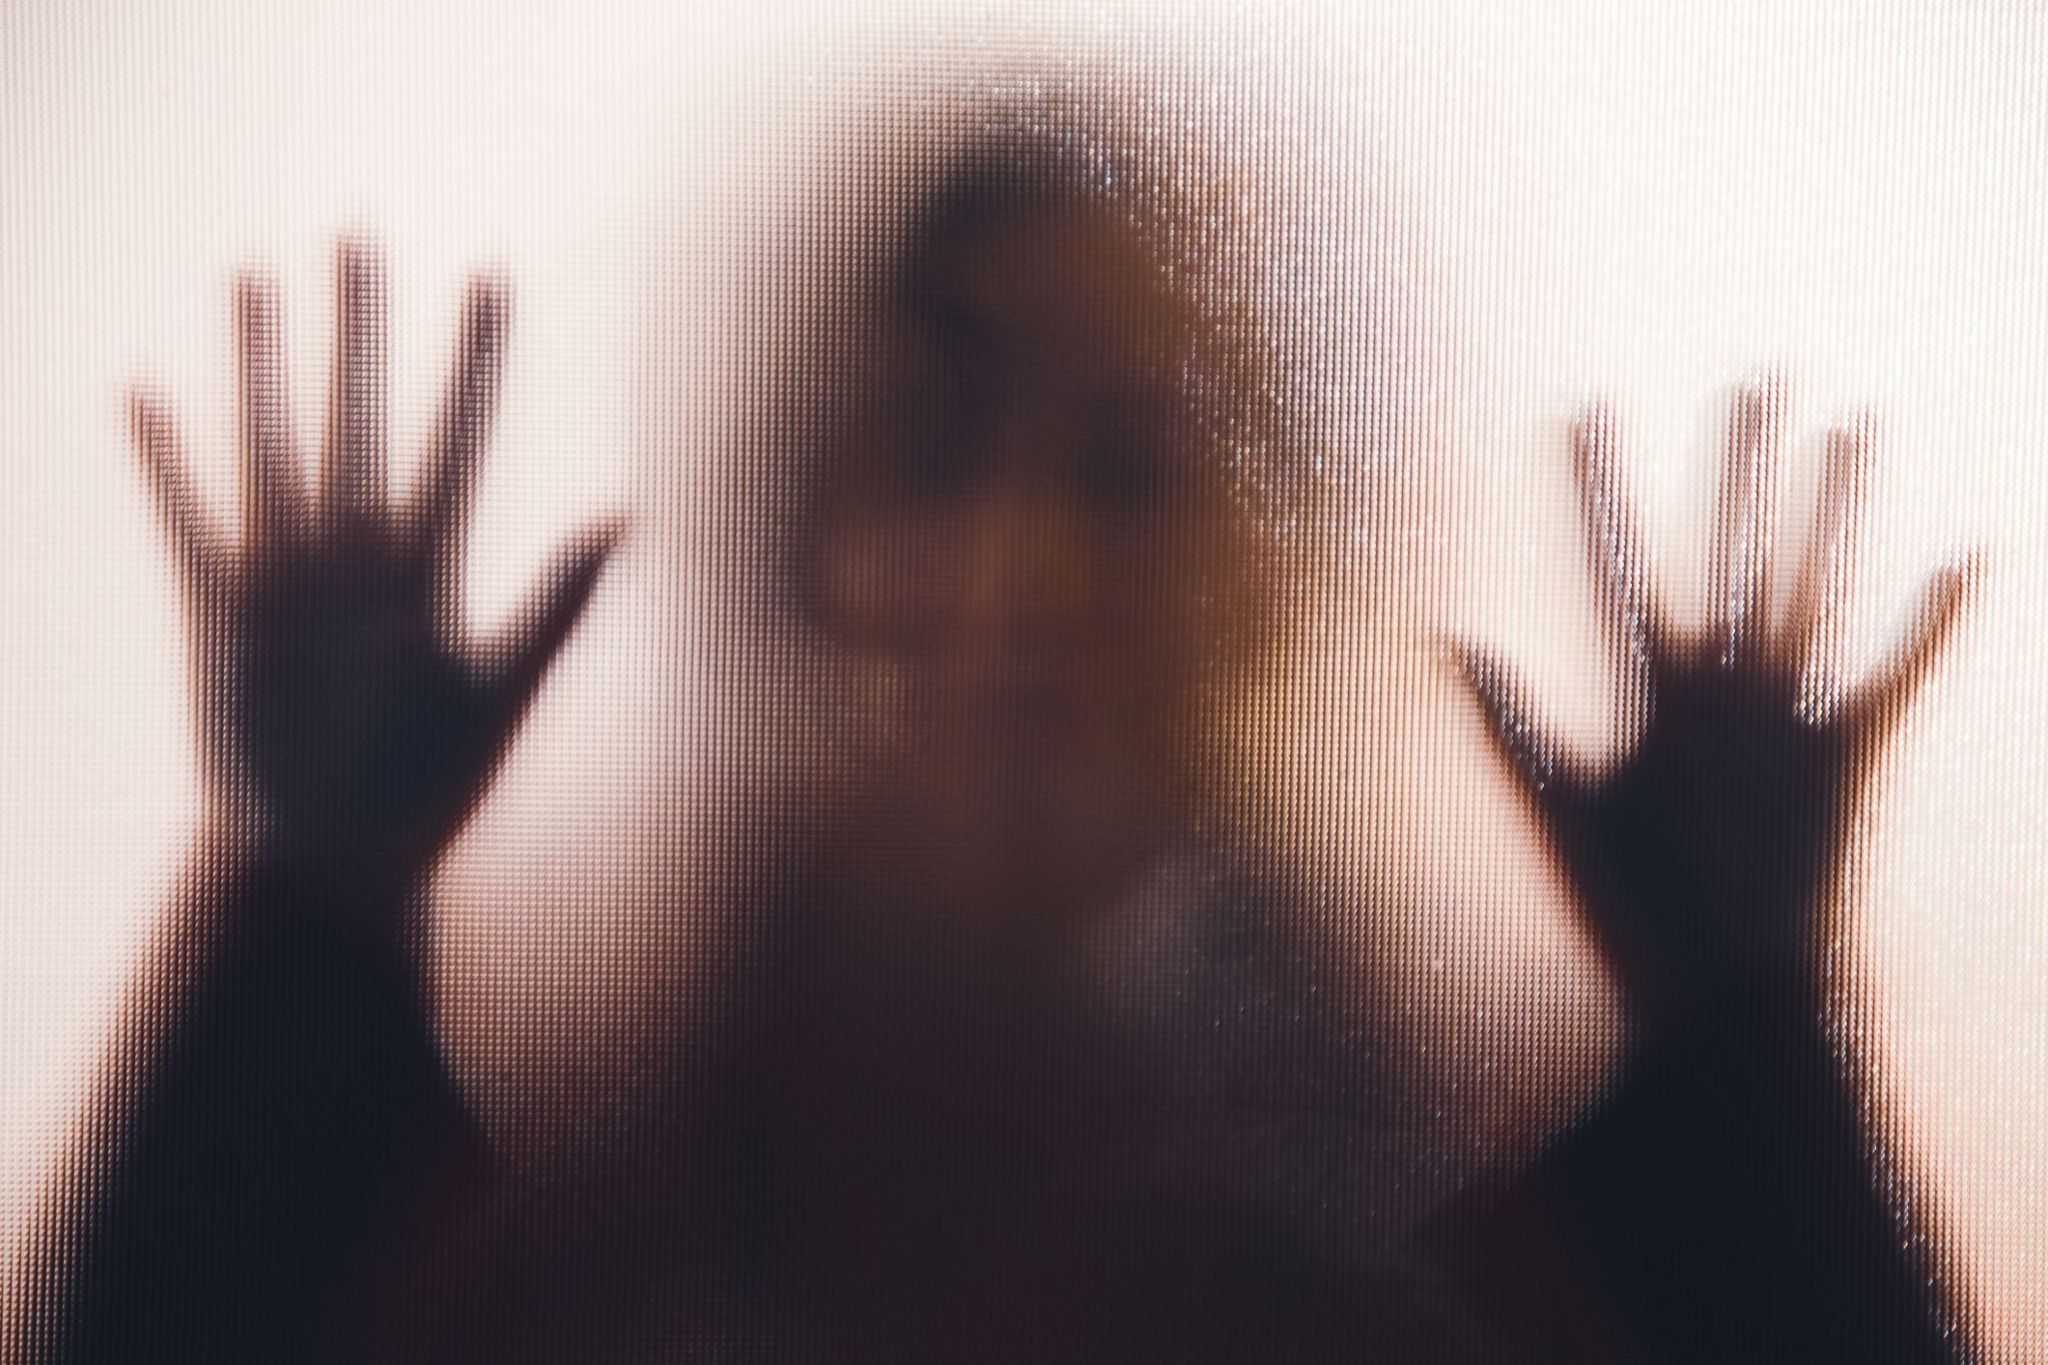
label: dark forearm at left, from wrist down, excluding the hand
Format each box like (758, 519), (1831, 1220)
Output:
(37, 855), (483, 1363)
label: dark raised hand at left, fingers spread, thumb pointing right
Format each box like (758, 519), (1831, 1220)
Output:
(133, 241), (616, 908)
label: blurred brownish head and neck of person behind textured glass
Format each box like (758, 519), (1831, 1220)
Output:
(801, 125), (1278, 913)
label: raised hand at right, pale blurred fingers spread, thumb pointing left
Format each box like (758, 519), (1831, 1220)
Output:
(1458, 389), (1966, 1015)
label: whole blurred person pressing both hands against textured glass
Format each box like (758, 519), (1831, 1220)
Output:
(12, 109), (1960, 1361)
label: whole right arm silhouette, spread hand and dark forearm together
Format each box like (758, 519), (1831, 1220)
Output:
(1462, 393), (1964, 1363)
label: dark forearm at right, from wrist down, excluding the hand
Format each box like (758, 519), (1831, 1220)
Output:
(1538, 974), (1956, 1363)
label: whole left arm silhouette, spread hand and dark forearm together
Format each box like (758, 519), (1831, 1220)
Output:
(31, 246), (610, 1363)
